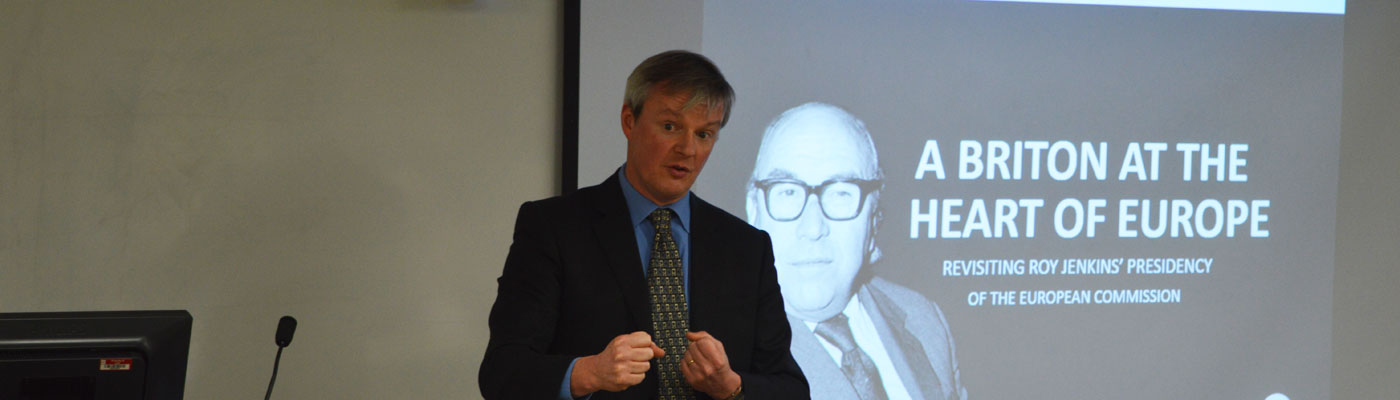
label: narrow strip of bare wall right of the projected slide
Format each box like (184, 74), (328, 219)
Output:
(1331, 0), (1400, 399)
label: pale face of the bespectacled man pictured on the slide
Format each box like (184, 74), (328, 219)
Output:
(748, 115), (876, 322)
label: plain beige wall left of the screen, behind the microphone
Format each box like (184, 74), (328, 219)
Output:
(0, 0), (560, 399)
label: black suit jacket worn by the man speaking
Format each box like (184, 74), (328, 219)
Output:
(477, 176), (808, 400)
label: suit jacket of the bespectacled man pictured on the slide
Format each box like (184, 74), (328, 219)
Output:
(788, 277), (967, 400)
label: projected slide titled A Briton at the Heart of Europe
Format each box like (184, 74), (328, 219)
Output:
(580, 1), (1343, 400)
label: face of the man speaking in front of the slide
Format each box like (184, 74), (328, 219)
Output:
(622, 85), (724, 206)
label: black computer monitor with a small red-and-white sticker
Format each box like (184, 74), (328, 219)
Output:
(0, 310), (193, 400)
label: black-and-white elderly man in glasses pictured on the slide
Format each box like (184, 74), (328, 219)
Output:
(746, 102), (967, 400)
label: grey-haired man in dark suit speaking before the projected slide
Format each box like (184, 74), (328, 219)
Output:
(479, 52), (808, 400)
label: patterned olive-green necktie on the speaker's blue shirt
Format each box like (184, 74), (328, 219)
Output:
(647, 208), (694, 400)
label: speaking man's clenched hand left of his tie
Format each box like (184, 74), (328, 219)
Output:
(568, 331), (666, 397)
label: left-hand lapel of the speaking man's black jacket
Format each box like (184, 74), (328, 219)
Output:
(594, 175), (651, 331)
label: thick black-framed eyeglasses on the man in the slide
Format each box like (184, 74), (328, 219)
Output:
(753, 179), (882, 222)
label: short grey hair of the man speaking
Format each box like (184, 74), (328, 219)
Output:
(623, 50), (734, 126)
